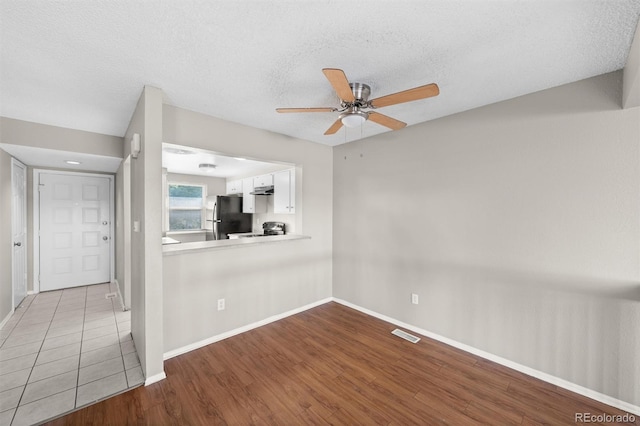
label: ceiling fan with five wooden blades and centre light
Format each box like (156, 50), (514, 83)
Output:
(276, 68), (440, 135)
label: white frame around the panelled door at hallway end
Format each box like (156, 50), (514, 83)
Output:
(33, 169), (116, 293)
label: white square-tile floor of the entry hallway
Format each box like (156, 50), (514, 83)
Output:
(0, 284), (144, 426)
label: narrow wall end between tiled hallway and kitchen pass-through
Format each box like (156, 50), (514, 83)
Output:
(124, 87), (164, 381)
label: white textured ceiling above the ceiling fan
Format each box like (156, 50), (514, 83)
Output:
(0, 0), (640, 145)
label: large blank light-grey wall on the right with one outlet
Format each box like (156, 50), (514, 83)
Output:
(333, 72), (640, 406)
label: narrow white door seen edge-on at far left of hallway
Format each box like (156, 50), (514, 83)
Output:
(11, 159), (27, 308)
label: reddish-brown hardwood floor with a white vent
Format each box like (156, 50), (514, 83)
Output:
(43, 303), (640, 425)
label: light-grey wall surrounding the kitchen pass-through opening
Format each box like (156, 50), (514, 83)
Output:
(163, 105), (332, 352)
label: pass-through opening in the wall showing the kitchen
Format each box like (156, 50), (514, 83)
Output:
(162, 143), (301, 244)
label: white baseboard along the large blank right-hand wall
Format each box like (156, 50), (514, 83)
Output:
(332, 297), (640, 415)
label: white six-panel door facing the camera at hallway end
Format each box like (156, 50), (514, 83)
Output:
(39, 173), (112, 291)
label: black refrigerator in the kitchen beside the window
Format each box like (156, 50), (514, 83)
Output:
(206, 195), (253, 241)
